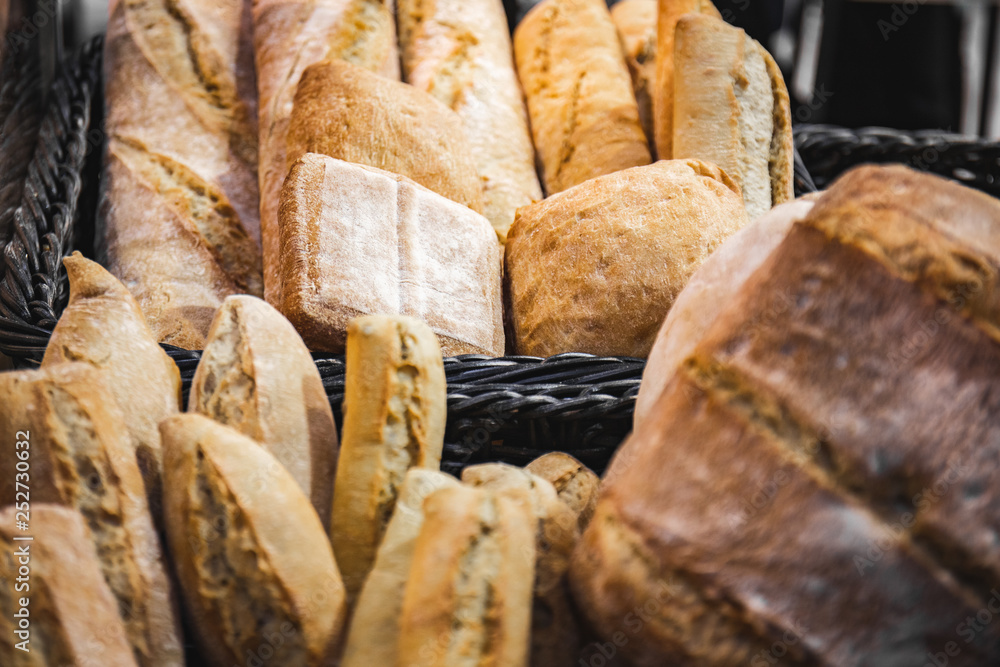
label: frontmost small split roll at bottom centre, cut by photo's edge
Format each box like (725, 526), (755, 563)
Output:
(396, 486), (535, 667)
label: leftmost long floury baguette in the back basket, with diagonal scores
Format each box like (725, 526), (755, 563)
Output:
(101, 0), (263, 350)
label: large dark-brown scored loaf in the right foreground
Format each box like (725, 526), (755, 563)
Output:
(572, 167), (1000, 666)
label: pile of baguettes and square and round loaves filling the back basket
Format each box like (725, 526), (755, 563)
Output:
(99, 0), (793, 356)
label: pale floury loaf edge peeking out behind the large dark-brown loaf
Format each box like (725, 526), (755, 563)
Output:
(636, 199), (813, 428)
